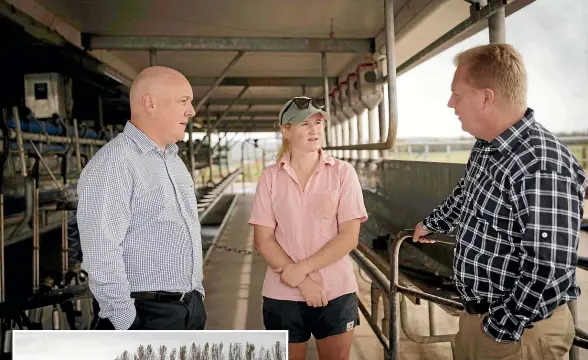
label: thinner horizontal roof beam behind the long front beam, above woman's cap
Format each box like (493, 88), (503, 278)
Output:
(187, 76), (337, 87)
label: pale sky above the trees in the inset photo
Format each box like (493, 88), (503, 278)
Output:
(13, 330), (287, 360)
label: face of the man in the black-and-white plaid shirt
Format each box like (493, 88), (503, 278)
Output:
(447, 66), (487, 138)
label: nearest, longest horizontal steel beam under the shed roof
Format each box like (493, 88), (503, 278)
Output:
(82, 33), (376, 54)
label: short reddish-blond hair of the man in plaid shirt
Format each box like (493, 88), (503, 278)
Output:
(453, 44), (527, 111)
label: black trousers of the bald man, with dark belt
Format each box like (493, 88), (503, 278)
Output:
(91, 290), (207, 330)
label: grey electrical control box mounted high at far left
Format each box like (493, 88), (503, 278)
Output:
(24, 73), (72, 119)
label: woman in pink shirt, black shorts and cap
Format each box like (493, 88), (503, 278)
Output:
(249, 97), (367, 360)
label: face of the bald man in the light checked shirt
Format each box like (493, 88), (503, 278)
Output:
(157, 78), (195, 144)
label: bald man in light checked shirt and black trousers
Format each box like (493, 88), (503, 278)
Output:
(77, 66), (206, 330)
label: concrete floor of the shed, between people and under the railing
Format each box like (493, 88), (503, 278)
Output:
(204, 191), (588, 360)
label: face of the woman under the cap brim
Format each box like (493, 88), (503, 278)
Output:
(282, 114), (325, 152)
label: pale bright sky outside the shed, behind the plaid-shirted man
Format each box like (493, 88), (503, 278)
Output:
(186, 0), (588, 145)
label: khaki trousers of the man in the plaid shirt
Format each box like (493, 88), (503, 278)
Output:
(454, 304), (575, 360)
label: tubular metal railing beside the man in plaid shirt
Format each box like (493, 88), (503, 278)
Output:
(350, 229), (588, 360)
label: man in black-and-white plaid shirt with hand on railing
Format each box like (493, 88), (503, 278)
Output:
(414, 44), (585, 360)
